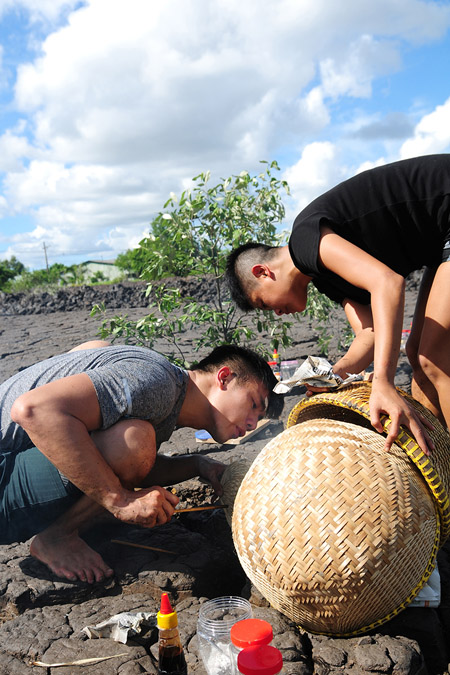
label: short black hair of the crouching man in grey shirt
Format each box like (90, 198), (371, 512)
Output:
(190, 344), (284, 419)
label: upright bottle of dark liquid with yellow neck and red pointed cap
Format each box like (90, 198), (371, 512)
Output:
(156, 593), (187, 675)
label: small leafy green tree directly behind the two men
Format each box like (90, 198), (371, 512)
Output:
(93, 162), (291, 361)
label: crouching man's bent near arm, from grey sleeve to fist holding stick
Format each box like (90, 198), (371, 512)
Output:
(11, 373), (178, 527)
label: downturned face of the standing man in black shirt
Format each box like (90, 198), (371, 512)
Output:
(249, 275), (309, 316)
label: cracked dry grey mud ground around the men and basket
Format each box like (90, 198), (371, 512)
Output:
(0, 278), (450, 675)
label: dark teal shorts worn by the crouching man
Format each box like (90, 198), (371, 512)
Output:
(0, 448), (82, 544)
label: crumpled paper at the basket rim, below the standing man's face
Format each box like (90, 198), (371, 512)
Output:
(273, 356), (363, 394)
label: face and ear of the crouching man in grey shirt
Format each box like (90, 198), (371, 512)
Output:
(208, 368), (269, 443)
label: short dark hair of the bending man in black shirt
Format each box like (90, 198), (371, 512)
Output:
(224, 241), (278, 312)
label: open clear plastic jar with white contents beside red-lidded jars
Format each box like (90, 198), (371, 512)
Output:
(197, 595), (252, 675)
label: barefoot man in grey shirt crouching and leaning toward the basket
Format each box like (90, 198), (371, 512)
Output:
(0, 341), (283, 583)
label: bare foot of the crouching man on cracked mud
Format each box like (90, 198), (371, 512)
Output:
(30, 529), (114, 584)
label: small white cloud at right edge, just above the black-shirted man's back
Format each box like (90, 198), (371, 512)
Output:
(400, 98), (450, 159)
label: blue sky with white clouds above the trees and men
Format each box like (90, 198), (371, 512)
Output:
(0, 0), (450, 269)
